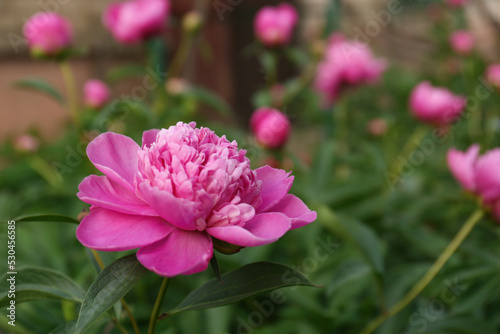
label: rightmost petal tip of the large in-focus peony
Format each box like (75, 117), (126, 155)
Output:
(268, 194), (317, 229)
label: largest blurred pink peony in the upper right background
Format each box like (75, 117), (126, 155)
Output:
(314, 33), (387, 105)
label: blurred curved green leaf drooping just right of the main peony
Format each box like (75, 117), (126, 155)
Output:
(316, 205), (384, 274)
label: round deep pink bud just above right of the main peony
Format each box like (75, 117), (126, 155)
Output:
(250, 107), (290, 148)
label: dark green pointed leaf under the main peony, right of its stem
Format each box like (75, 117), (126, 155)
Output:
(167, 262), (315, 315)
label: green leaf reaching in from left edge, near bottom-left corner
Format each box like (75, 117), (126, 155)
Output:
(0, 267), (85, 307)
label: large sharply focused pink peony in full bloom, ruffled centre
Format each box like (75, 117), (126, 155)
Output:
(76, 122), (316, 277)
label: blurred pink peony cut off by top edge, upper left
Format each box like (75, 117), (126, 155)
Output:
(103, 0), (170, 44)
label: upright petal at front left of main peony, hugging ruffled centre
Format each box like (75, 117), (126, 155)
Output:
(139, 183), (199, 231)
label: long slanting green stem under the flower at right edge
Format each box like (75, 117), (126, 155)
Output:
(360, 208), (484, 334)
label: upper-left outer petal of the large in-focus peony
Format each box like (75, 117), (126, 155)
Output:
(87, 132), (140, 191)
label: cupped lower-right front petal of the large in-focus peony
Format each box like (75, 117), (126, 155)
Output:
(206, 212), (291, 247)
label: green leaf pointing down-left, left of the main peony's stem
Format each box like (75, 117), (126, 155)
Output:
(75, 254), (148, 334)
